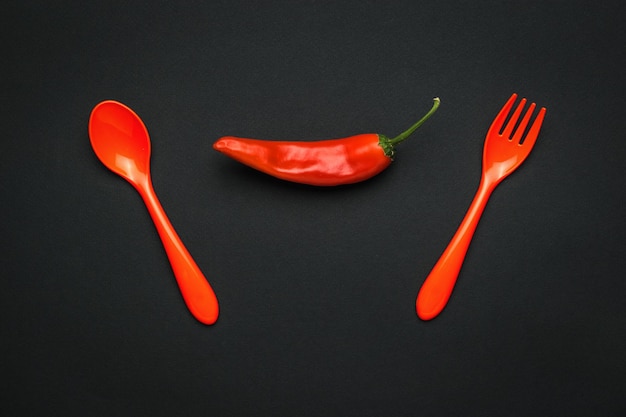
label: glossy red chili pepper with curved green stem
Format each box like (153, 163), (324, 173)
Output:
(213, 98), (440, 186)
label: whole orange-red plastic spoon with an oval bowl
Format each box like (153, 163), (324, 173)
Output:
(89, 100), (219, 324)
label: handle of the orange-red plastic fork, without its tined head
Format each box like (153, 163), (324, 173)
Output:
(415, 178), (495, 320)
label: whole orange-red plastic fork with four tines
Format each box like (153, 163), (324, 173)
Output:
(415, 94), (546, 320)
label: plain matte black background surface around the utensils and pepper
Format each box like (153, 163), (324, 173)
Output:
(0, 0), (626, 417)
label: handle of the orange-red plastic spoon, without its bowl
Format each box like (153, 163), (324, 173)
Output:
(140, 181), (219, 325)
